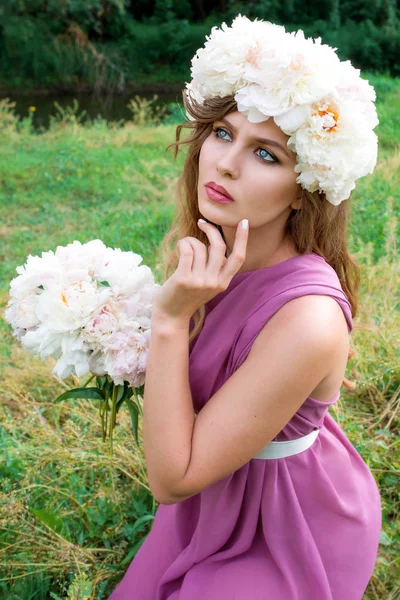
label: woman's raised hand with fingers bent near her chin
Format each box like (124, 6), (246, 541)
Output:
(152, 221), (249, 323)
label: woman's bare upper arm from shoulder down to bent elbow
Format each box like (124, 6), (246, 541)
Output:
(164, 295), (348, 503)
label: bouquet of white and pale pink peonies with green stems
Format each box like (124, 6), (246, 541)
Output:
(5, 240), (160, 452)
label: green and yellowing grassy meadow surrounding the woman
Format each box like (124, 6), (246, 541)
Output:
(0, 76), (400, 600)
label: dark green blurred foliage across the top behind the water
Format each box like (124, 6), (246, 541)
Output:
(0, 0), (400, 90)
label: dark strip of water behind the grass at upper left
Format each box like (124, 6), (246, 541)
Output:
(3, 91), (182, 129)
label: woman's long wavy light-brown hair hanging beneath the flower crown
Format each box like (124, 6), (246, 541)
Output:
(159, 92), (360, 389)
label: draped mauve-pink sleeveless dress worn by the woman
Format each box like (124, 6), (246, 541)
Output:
(109, 253), (382, 600)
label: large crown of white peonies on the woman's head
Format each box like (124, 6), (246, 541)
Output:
(186, 15), (379, 206)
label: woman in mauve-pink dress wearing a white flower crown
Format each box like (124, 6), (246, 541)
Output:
(110, 16), (381, 600)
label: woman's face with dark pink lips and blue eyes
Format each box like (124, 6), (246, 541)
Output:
(198, 111), (301, 233)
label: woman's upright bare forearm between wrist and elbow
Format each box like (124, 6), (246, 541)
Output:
(143, 318), (195, 502)
